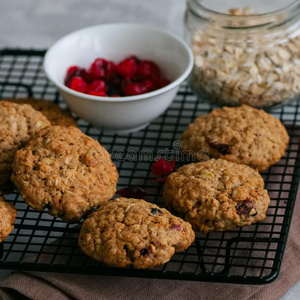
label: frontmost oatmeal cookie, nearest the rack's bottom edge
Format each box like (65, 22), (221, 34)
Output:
(78, 198), (195, 269)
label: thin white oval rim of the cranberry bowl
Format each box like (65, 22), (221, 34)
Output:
(43, 23), (194, 103)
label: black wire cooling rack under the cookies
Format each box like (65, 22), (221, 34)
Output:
(0, 49), (300, 284)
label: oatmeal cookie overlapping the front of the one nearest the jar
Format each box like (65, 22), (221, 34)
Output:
(163, 159), (270, 232)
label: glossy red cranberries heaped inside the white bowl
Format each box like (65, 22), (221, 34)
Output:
(65, 56), (171, 98)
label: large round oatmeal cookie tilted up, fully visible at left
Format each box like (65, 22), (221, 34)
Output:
(12, 126), (119, 222)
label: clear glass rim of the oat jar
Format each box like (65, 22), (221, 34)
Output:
(187, 0), (300, 29)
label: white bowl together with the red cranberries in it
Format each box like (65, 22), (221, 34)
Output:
(44, 23), (193, 132)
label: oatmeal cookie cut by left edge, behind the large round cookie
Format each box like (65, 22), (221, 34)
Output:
(0, 101), (51, 190)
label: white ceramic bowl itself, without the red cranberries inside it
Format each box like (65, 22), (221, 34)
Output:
(44, 23), (193, 132)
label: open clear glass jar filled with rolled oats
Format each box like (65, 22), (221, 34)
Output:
(185, 0), (300, 108)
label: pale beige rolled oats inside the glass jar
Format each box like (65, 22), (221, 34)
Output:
(191, 8), (300, 107)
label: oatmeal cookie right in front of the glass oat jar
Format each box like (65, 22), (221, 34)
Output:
(181, 105), (289, 171)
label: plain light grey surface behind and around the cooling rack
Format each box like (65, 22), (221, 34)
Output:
(0, 0), (300, 300)
